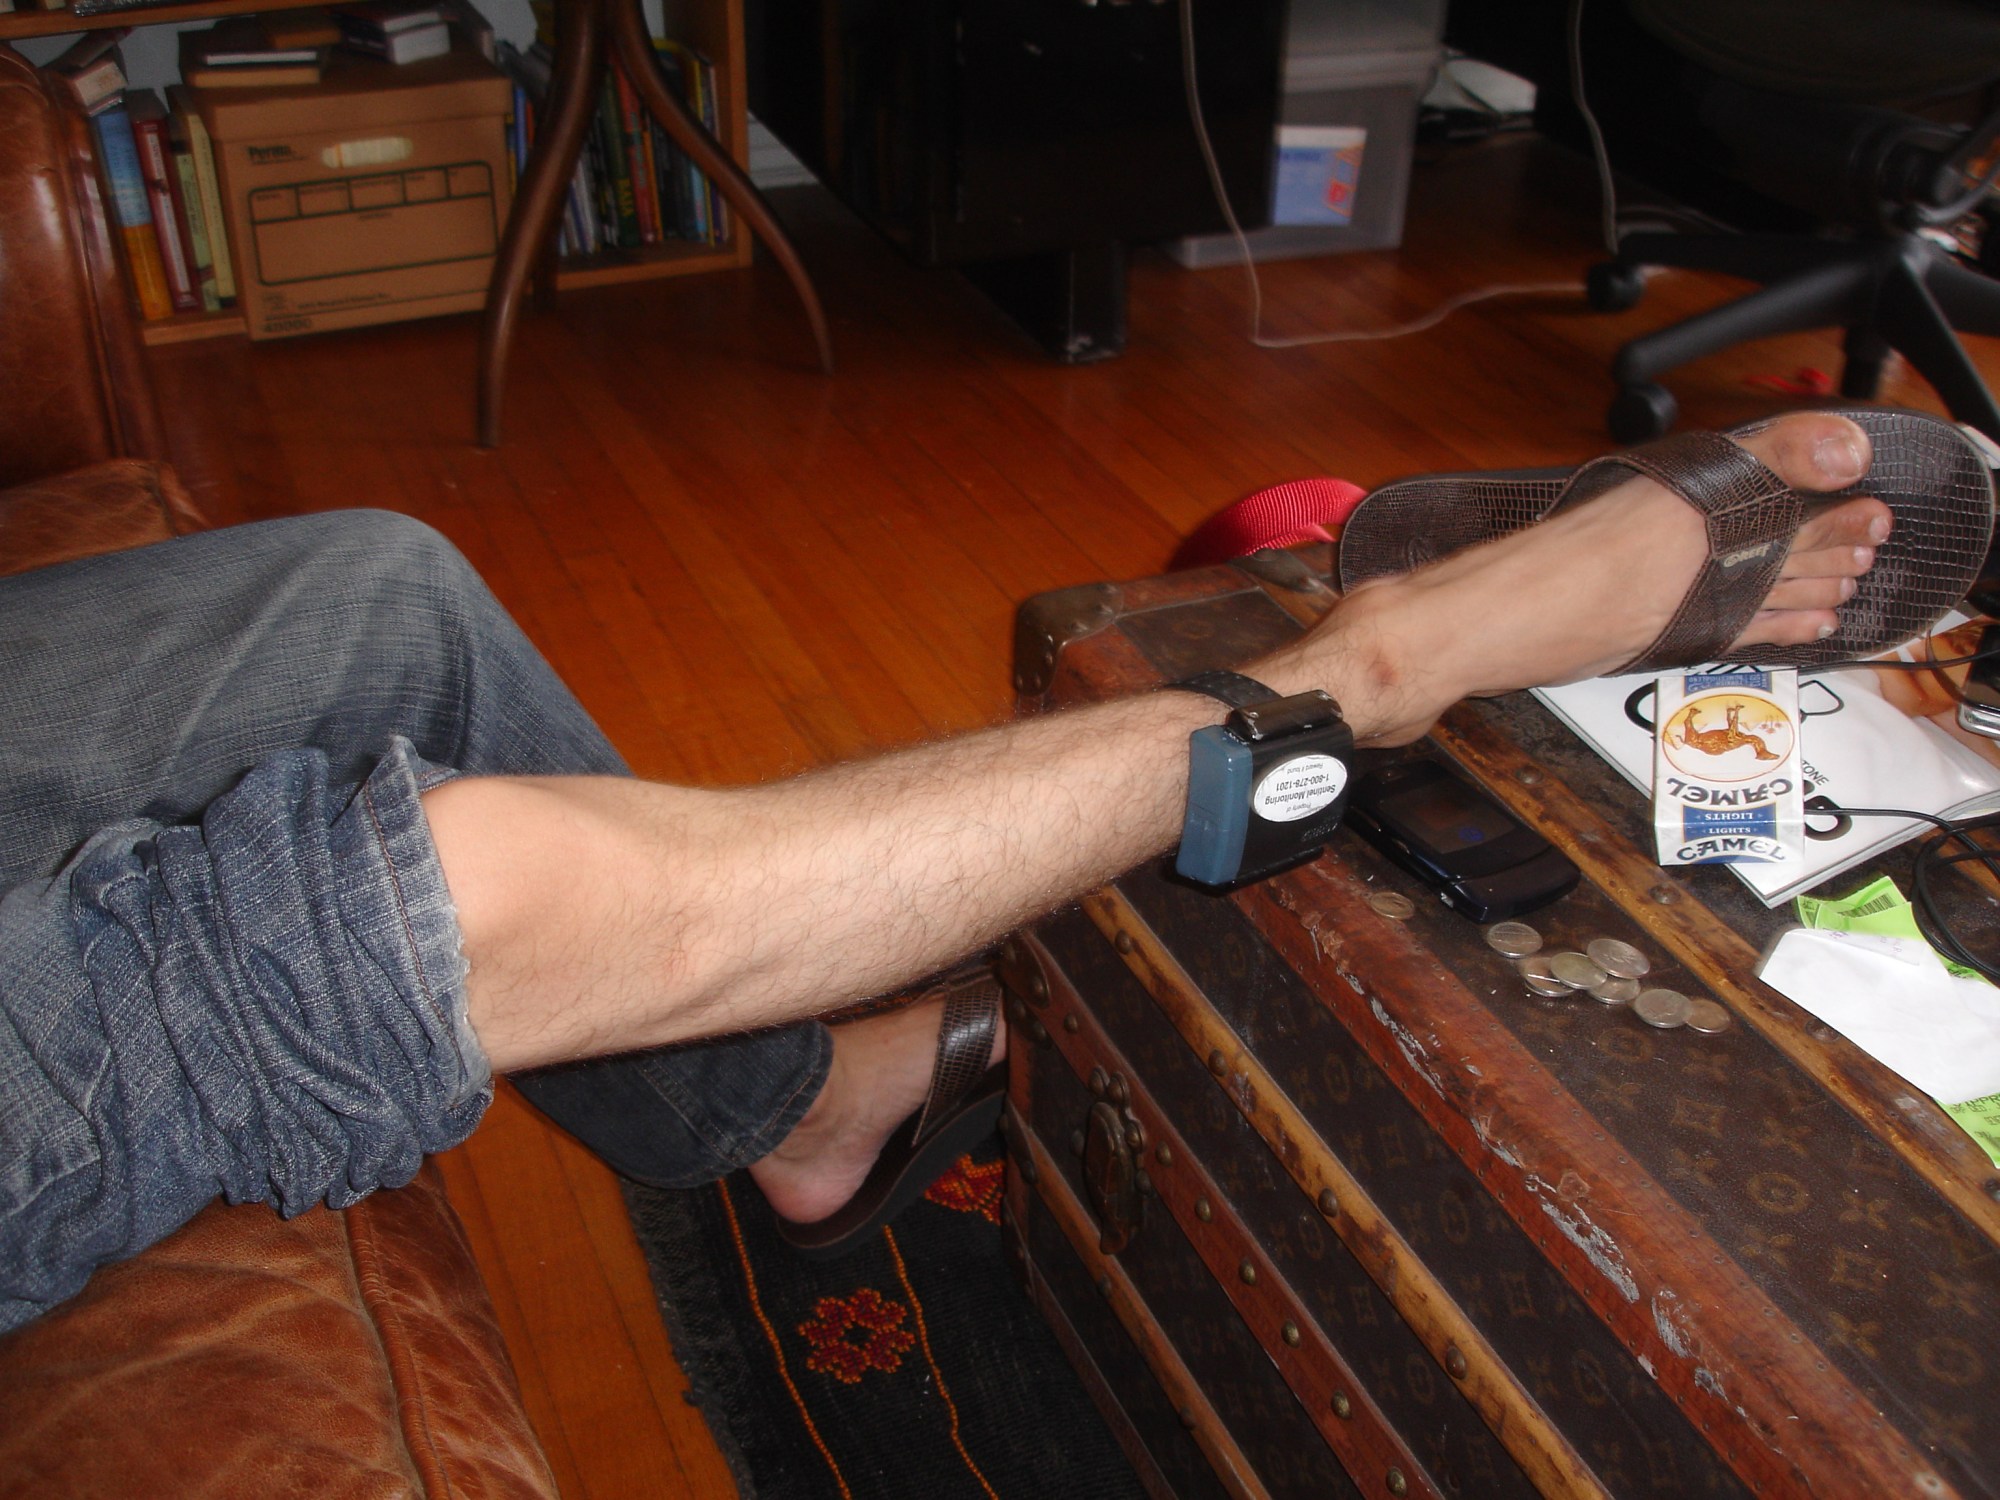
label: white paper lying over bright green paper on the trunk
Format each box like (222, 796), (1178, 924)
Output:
(1760, 928), (2000, 1100)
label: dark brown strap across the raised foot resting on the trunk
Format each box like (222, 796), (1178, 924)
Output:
(1556, 432), (1806, 672)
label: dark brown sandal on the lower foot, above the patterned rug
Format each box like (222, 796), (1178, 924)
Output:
(778, 962), (1006, 1260)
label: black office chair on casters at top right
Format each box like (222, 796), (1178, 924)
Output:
(1572, 0), (2000, 442)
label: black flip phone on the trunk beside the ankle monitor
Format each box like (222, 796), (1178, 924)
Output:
(1348, 756), (1578, 922)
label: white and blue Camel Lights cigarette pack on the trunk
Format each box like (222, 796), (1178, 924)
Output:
(1652, 668), (1806, 866)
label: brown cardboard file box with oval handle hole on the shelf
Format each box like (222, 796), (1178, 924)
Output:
(198, 54), (512, 338)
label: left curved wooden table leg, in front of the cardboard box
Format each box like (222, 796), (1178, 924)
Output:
(478, 0), (604, 448)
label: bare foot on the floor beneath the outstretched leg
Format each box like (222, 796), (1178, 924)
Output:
(750, 1000), (1006, 1224)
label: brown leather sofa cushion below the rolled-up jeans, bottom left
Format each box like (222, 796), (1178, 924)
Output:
(0, 1162), (556, 1500)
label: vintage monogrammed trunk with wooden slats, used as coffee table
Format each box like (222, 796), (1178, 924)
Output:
(1002, 548), (2000, 1500)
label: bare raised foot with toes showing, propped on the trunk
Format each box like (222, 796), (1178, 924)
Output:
(1266, 412), (1892, 744)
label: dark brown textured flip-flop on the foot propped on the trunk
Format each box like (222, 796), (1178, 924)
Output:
(1340, 406), (1994, 672)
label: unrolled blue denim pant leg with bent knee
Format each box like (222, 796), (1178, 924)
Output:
(0, 512), (830, 1304)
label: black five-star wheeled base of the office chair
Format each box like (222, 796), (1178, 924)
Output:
(1590, 232), (2000, 442)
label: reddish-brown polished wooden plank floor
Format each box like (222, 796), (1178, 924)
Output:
(154, 138), (1996, 1500)
